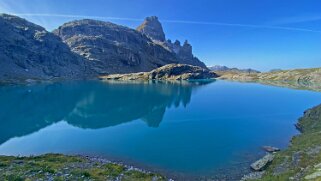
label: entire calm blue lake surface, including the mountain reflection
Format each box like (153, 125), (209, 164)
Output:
(0, 81), (321, 179)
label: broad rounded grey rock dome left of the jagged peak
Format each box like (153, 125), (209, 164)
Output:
(54, 20), (178, 74)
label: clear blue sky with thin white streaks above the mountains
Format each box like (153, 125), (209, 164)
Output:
(0, 0), (321, 70)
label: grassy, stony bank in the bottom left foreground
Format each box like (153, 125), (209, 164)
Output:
(0, 154), (165, 181)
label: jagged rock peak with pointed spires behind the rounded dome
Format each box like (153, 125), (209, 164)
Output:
(136, 16), (206, 68)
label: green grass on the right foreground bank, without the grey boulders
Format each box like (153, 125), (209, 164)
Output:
(261, 105), (321, 181)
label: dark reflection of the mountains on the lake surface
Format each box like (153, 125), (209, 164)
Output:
(0, 81), (213, 144)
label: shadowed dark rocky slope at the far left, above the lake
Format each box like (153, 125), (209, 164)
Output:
(0, 14), (86, 82)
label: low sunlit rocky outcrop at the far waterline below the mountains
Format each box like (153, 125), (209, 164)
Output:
(101, 64), (216, 80)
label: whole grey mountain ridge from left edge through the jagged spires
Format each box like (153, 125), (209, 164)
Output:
(0, 14), (209, 83)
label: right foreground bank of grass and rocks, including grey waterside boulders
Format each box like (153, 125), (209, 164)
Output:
(242, 105), (321, 181)
